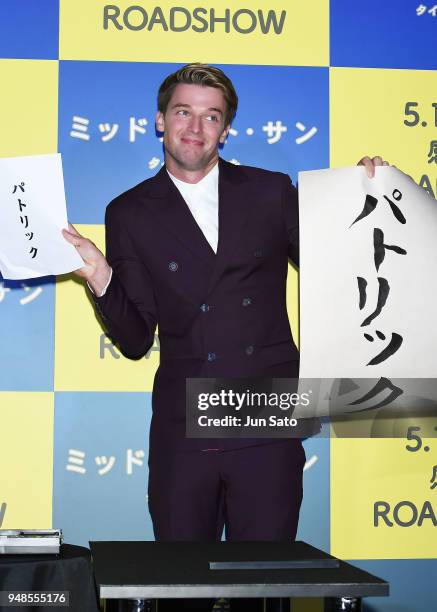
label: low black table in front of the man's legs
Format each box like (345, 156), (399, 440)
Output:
(90, 542), (389, 610)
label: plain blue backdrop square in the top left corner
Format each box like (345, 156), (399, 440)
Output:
(0, 0), (59, 59)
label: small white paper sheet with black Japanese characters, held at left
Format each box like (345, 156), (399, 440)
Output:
(0, 154), (84, 279)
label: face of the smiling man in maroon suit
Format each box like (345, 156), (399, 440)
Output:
(156, 83), (230, 172)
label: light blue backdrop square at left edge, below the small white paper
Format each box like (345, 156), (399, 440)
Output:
(0, 276), (55, 391)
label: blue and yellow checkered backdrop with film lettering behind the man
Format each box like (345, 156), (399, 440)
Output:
(0, 0), (437, 612)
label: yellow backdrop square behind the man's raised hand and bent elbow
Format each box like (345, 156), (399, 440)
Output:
(55, 225), (159, 391)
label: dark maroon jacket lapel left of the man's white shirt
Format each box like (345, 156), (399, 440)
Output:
(145, 166), (215, 265)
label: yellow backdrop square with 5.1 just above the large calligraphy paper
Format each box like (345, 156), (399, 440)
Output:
(330, 68), (437, 196)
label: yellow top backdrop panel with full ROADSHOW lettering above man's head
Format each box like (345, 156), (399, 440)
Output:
(60, 0), (329, 66)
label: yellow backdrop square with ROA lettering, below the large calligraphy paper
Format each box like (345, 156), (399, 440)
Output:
(331, 438), (437, 559)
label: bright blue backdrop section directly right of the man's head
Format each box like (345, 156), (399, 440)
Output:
(214, 66), (329, 184)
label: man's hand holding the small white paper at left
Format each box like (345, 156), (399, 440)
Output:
(62, 223), (111, 295)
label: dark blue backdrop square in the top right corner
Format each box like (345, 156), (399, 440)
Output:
(330, 0), (437, 69)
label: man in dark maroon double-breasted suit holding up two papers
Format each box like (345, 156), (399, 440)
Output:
(64, 64), (386, 612)
